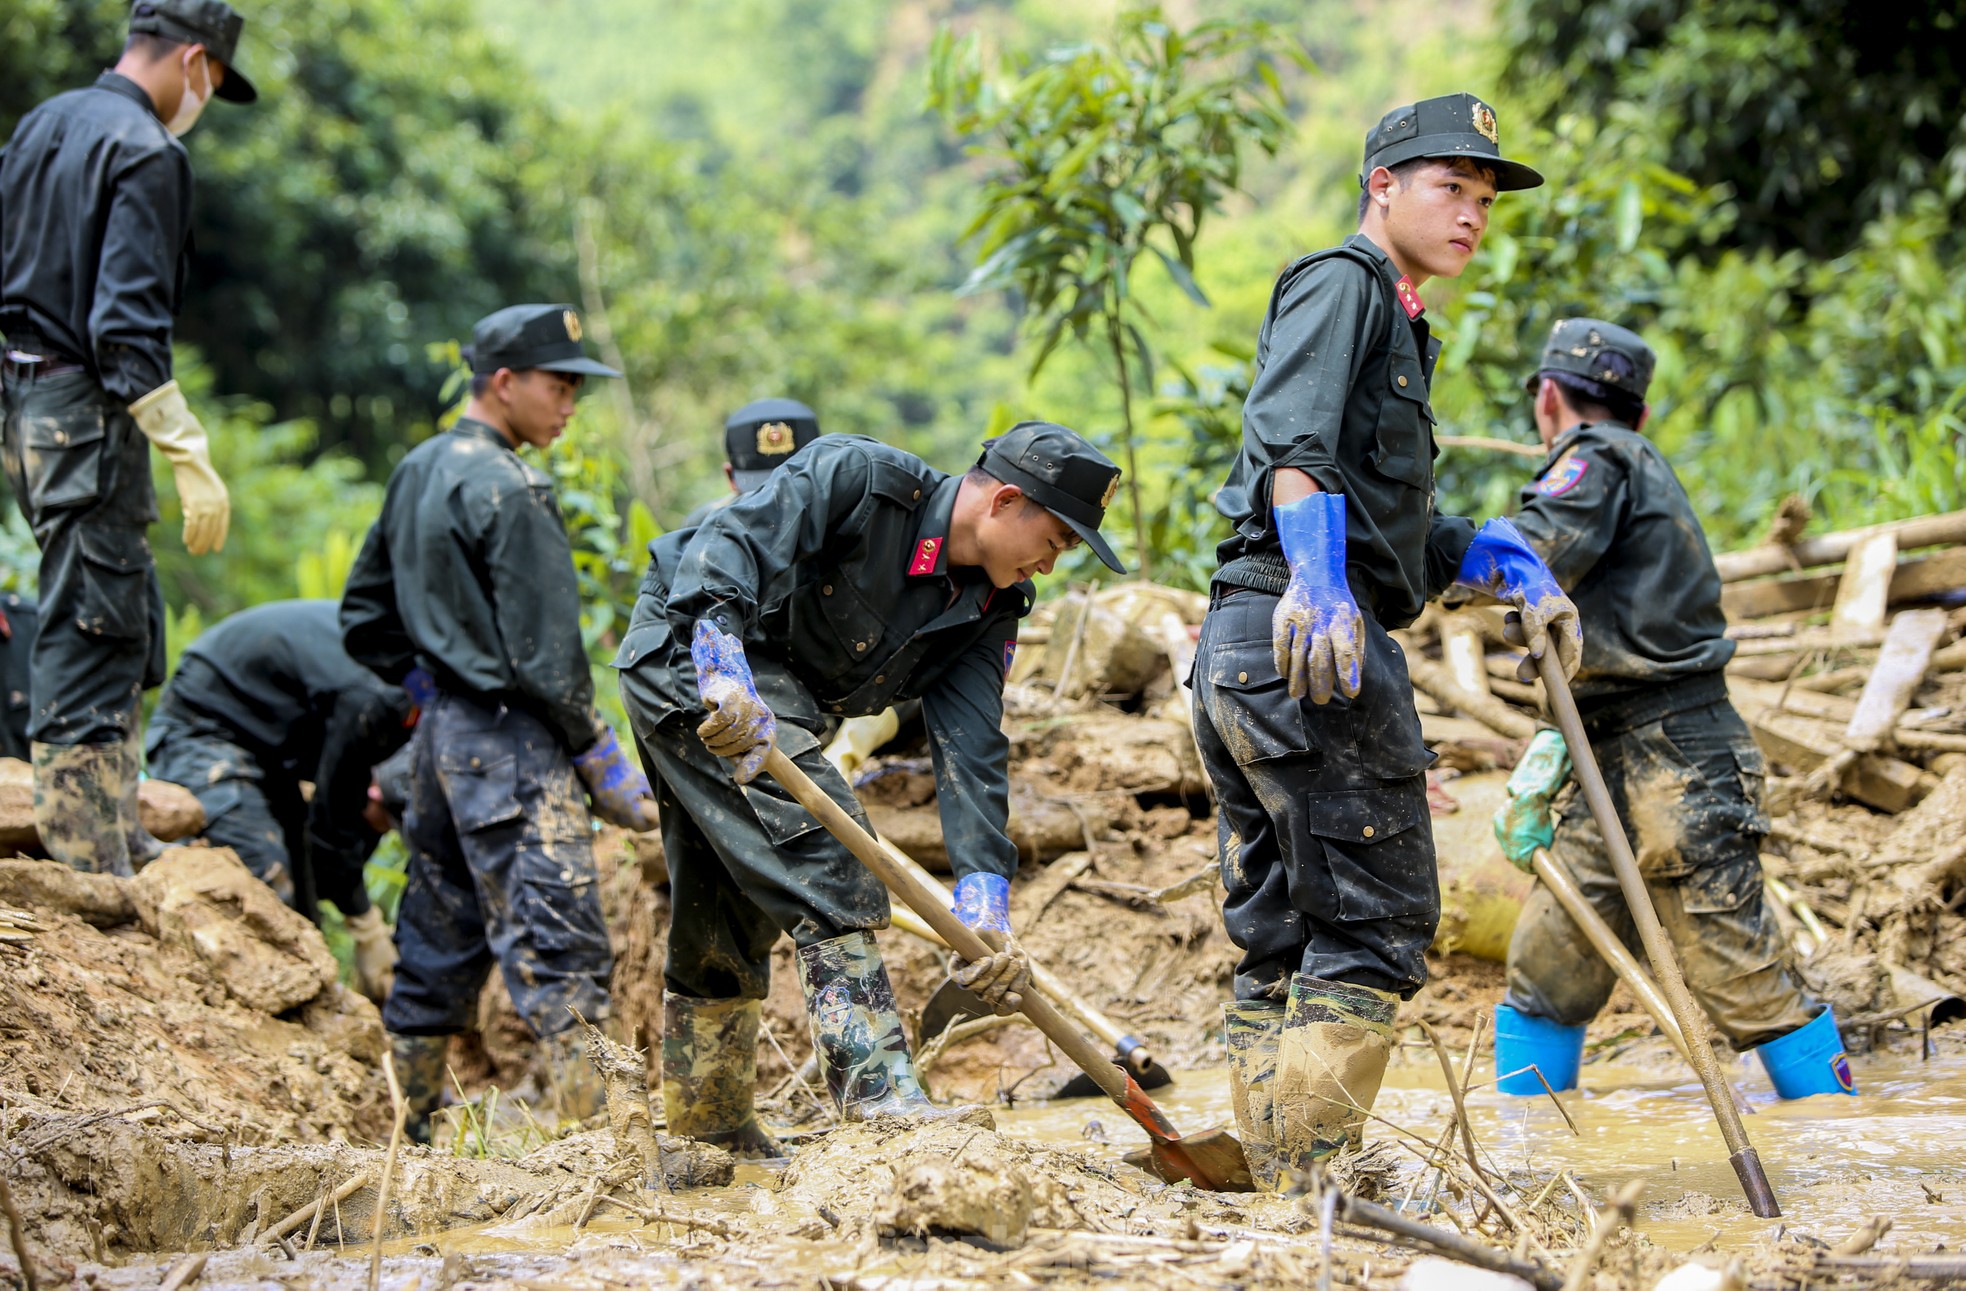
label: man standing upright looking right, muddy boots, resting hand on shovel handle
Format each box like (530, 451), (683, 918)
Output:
(1191, 94), (1579, 1187)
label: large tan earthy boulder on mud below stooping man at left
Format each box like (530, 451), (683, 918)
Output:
(130, 847), (336, 1014)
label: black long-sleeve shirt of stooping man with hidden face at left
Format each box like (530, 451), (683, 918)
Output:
(151, 601), (411, 912)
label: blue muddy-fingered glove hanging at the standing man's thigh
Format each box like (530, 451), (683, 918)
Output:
(1270, 493), (1364, 703)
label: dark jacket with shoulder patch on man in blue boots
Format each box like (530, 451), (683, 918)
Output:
(1516, 421), (1734, 700)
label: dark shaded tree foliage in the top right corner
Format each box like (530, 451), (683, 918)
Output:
(1496, 0), (1966, 255)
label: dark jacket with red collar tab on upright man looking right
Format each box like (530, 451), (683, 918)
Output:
(1215, 234), (1475, 627)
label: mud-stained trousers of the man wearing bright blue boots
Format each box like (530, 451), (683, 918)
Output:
(1508, 703), (1821, 1049)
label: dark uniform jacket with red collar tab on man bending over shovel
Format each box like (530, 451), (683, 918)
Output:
(615, 434), (1032, 874)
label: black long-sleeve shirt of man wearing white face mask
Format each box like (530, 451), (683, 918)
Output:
(0, 73), (193, 405)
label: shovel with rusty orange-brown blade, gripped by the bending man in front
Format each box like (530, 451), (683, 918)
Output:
(765, 749), (1254, 1193)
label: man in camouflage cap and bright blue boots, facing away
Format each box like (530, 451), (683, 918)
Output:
(1494, 318), (1852, 1098)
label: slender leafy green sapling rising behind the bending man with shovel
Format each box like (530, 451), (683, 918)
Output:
(930, 6), (1305, 576)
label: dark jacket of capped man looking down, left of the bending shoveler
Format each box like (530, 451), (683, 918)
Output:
(342, 417), (594, 753)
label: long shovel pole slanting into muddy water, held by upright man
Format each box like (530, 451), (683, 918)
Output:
(1535, 648), (1781, 1218)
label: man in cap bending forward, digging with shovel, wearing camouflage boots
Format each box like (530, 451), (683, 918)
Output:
(615, 422), (1125, 1155)
